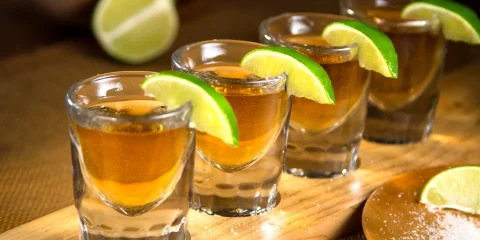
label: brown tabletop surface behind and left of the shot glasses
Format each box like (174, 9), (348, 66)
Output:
(0, 0), (344, 233)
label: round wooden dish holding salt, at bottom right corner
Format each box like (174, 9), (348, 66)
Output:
(362, 167), (480, 240)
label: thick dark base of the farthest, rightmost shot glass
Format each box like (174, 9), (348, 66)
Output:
(363, 95), (438, 144)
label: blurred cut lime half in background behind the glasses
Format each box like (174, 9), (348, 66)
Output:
(93, 0), (178, 64)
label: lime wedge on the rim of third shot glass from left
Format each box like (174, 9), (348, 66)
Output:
(322, 20), (398, 78)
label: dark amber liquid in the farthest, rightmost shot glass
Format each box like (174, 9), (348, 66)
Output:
(367, 9), (445, 111)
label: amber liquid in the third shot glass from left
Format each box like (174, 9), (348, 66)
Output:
(282, 35), (368, 132)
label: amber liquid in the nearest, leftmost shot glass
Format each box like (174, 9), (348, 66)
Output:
(72, 100), (190, 208)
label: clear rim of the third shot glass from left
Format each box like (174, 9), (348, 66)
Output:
(259, 12), (358, 54)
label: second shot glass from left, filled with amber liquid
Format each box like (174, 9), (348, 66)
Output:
(172, 40), (291, 216)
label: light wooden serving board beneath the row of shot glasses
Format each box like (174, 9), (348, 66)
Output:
(0, 62), (480, 240)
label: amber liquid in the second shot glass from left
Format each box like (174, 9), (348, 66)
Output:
(195, 63), (288, 171)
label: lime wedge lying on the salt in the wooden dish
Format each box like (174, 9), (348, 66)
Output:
(420, 166), (480, 214)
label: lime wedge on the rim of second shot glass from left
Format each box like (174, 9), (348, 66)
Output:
(240, 46), (335, 104)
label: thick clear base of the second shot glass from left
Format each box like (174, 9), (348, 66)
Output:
(191, 156), (283, 217)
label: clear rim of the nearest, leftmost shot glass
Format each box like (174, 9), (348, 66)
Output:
(65, 71), (192, 121)
